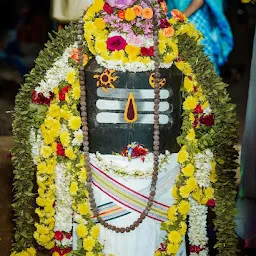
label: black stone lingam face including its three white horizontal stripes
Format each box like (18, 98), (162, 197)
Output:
(85, 59), (183, 154)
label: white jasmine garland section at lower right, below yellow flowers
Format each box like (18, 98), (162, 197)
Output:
(188, 198), (208, 251)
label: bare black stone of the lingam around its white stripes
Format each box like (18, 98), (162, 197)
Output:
(85, 60), (183, 153)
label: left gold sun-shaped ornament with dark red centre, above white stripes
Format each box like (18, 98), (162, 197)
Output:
(93, 69), (118, 92)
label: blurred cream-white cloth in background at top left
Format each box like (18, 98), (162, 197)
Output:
(52, 0), (94, 22)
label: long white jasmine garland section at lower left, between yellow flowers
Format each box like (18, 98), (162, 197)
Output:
(54, 164), (73, 247)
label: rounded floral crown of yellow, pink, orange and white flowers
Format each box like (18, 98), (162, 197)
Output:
(84, 0), (195, 72)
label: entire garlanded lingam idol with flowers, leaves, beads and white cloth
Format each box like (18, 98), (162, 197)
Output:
(12, 0), (237, 256)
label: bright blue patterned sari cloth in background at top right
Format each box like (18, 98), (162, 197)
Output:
(167, 0), (233, 71)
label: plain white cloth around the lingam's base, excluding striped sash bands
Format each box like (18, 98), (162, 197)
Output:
(73, 154), (186, 256)
